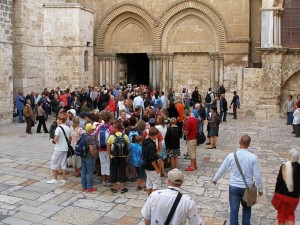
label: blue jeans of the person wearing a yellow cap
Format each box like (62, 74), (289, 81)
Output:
(81, 157), (95, 190)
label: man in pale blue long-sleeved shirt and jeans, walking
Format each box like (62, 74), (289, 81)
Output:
(212, 135), (263, 225)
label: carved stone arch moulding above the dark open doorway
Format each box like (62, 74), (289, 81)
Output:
(97, 4), (154, 52)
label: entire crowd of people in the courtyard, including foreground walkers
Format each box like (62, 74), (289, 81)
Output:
(16, 84), (300, 225)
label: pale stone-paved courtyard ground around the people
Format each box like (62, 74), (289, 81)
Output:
(0, 115), (300, 225)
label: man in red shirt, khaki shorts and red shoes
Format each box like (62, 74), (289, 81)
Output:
(183, 110), (198, 171)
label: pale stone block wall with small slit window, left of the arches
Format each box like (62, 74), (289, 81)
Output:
(14, 0), (93, 94)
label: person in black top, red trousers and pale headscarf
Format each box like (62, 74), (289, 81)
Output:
(274, 149), (300, 225)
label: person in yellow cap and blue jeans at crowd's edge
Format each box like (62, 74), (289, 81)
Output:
(81, 123), (97, 192)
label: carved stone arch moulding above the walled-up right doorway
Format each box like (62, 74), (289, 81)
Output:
(154, 1), (228, 52)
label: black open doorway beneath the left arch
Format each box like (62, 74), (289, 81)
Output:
(126, 53), (149, 85)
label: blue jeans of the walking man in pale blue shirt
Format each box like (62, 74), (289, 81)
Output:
(229, 185), (251, 225)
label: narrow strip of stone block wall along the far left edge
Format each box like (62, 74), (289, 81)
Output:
(0, 0), (13, 125)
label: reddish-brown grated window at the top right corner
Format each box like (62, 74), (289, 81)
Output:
(281, 0), (300, 48)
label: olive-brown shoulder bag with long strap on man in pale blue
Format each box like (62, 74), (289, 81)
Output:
(234, 152), (257, 207)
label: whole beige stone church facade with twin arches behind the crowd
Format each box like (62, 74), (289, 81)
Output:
(0, 0), (300, 124)
